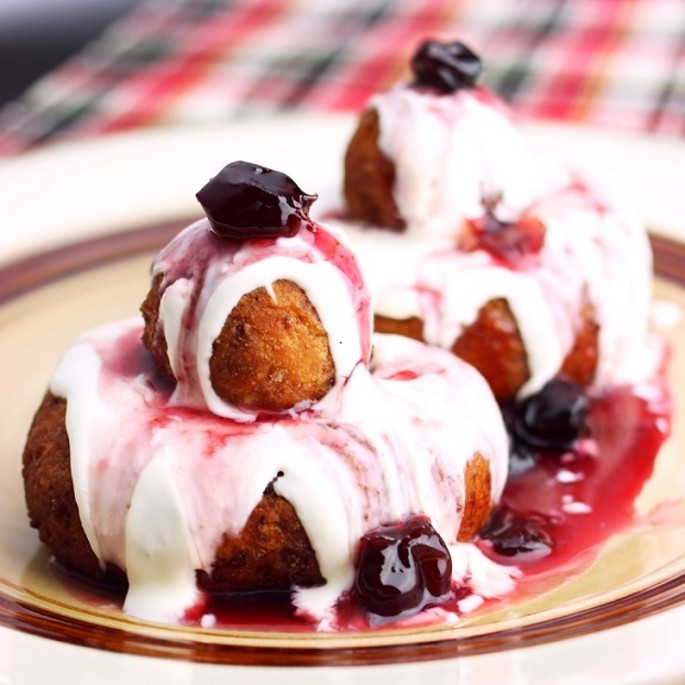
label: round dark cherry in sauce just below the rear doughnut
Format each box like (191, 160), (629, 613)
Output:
(513, 378), (589, 451)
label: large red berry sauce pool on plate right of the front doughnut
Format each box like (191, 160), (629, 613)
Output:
(478, 374), (671, 584)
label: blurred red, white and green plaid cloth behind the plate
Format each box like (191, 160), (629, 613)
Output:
(0, 0), (685, 154)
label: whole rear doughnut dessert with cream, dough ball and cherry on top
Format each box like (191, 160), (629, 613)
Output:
(342, 41), (652, 403)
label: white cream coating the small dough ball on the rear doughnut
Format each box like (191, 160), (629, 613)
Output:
(370, 86), (555, 238)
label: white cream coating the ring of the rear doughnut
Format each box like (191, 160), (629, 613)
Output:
(336, 176), (652, 396)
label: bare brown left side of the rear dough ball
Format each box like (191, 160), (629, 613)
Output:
(343, 109), (405, 231)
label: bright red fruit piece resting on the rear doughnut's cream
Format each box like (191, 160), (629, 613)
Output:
(464, 208), (546, 264)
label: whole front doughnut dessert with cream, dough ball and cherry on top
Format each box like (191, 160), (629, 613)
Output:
(25, 162), (515, 629)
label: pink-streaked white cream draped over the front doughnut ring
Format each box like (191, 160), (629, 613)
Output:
(51, 322), (511, 621)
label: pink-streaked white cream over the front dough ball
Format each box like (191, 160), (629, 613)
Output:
(152, 220), (371, 421)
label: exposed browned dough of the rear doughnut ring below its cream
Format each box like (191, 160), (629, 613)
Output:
(374, 298), (599, 404)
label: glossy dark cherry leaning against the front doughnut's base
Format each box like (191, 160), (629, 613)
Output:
(354, 516), (452, 617)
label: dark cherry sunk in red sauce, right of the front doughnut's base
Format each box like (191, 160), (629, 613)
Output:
(479, 506), (554, 560)
